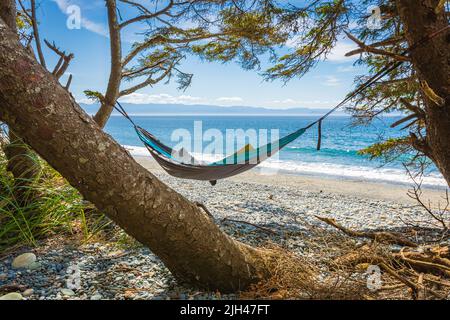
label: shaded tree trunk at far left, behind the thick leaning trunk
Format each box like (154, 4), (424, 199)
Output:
(0, 0), (39, 196)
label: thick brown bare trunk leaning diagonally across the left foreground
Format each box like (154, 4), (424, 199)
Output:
(0, 19), (278, 291)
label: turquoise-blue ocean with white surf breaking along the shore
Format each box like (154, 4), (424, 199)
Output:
(106, 115), (446, 188)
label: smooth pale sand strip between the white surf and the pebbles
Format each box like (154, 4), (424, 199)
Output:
(135, 156), (445, 205)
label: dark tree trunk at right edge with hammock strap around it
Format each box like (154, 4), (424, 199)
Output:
(397, 0), (450, 186)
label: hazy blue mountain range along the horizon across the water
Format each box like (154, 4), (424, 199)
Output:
(80, 103), (345, 115)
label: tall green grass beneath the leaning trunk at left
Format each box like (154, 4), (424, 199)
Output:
(0, 144), (110, 251)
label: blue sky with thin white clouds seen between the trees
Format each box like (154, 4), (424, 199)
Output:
(33, 0), (365, 108)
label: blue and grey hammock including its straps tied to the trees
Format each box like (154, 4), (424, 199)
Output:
(115, 26), (449, 185)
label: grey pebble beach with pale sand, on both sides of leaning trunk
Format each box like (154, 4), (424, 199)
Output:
(0, 158), (448, 300)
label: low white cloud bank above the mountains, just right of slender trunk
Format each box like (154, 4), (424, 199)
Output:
(120, 93), (207, 104)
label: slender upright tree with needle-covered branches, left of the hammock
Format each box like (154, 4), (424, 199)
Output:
(94, 0), (296, 126)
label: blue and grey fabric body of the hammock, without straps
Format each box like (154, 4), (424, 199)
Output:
(135, 126), (306, 185)
